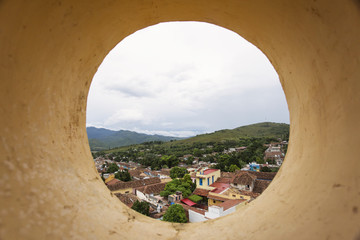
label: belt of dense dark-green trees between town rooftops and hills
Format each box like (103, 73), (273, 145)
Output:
(94, 138), (276, 171)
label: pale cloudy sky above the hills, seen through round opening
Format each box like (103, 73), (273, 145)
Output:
(87, 22), (289, 137)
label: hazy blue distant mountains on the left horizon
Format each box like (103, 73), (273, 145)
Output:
(86, 127), (184, 151)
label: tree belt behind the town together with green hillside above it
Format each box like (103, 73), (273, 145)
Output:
(93, 123), (289, 172)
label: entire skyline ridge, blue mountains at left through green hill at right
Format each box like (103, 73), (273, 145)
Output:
(86, 122), (290, 151)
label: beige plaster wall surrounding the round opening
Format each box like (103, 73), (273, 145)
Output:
(0, 0), (360, 239)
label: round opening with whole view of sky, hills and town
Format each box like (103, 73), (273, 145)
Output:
(87, 22), (289, 222)
